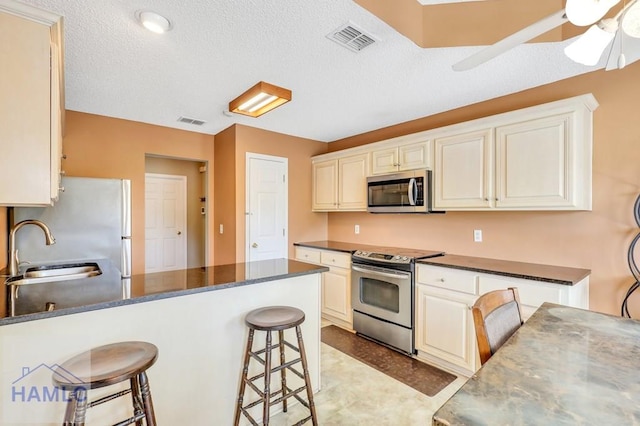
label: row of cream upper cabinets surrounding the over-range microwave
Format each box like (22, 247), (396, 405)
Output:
(312, 94), (598, 211)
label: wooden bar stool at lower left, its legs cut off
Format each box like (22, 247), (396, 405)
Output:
(53, 342), (158, 426)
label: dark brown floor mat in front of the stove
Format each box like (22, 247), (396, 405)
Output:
(322, 325), (456, 396)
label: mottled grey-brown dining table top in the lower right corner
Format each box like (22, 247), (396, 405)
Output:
(432, 303), (640, 426)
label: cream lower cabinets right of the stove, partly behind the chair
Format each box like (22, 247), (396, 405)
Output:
(415, 264), (589, 376)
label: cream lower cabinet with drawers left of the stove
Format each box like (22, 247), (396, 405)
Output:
(296, 247), (353, 329)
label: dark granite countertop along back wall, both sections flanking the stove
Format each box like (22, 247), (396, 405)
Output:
(294, 241), (591, 285)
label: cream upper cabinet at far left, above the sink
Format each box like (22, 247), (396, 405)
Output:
(0, 0), (64, 206)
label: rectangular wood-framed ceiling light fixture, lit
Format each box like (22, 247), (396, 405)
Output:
(229, 81), (291, 117)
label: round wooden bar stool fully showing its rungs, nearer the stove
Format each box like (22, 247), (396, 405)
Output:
(234, 306), (318, 426)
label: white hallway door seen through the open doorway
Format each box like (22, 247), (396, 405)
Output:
(145, 173), (187, 273)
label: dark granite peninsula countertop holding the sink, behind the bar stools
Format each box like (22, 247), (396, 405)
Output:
(0, 259), (328, 326)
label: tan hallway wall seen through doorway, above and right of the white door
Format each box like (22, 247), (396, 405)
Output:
(145, 156), (207, 268)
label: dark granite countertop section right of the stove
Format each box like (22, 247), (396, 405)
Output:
(418, 254), (591, 285)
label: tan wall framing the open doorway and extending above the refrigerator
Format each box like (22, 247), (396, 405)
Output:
(62, 111), (214, 274)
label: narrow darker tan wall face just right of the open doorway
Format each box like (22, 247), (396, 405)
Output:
(213, 126), (236, 265)
